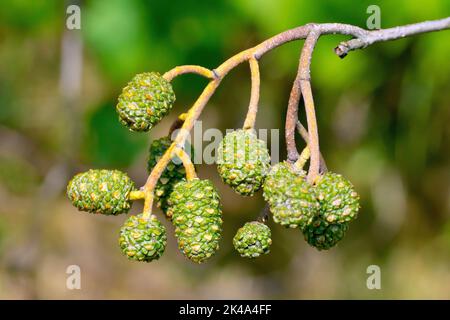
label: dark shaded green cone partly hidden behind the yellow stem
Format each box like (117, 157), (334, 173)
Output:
(147, 137), (194, 219)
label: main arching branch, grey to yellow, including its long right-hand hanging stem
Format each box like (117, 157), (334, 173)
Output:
(142, 18), (450, 214)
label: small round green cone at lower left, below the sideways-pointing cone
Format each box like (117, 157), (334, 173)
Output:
(119, 214), (167, 262)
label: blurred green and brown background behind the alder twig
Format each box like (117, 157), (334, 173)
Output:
(0, 0), (450, 299)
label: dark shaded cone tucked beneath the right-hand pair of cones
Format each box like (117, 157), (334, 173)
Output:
(303, 216), (348, 250)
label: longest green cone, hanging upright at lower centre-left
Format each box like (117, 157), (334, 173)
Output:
(169, 178), (222, 263)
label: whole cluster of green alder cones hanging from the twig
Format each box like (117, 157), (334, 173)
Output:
(67, 72), (359, 263)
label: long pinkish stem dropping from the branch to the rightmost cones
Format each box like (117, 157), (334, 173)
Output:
(300, 30), (320, 183)
